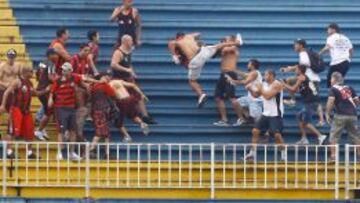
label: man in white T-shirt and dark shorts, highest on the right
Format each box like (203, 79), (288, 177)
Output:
(319, 23), (353, 87)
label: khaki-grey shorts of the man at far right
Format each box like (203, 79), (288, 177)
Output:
(330, 115), (360, 145)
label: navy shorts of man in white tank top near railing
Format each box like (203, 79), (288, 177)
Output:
(255, 115), (283, 134)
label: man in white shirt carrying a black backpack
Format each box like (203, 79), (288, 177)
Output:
(281, 39), (325, 127)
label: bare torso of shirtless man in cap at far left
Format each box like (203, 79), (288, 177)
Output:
(0, 62), (22, 89)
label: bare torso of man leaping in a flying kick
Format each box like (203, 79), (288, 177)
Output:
(176, 35), (200, 61)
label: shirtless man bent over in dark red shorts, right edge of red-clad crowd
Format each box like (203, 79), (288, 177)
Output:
(109, 80), (150, 142)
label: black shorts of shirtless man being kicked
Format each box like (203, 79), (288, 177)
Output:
(215, 71), (238, 99)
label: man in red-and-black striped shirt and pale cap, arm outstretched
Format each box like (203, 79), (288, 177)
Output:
(48, 63), (96, 161)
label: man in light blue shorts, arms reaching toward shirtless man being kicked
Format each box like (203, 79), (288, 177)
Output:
(227, 59), (263, 126)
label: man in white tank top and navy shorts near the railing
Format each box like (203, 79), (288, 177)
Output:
(245, 70), (286, 161)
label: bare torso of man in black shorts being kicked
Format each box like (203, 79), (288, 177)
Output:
(221, 46), (239, 72)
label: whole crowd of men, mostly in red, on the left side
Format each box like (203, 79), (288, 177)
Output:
(0, 0), (156, 161)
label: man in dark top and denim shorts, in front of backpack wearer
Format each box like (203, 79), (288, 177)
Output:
(283, 65), (326, 145)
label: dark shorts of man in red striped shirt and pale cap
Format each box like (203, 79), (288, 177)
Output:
(55, 107), (76, 134)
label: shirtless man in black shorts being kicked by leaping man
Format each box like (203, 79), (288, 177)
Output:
(214, 36), (241, 126)
